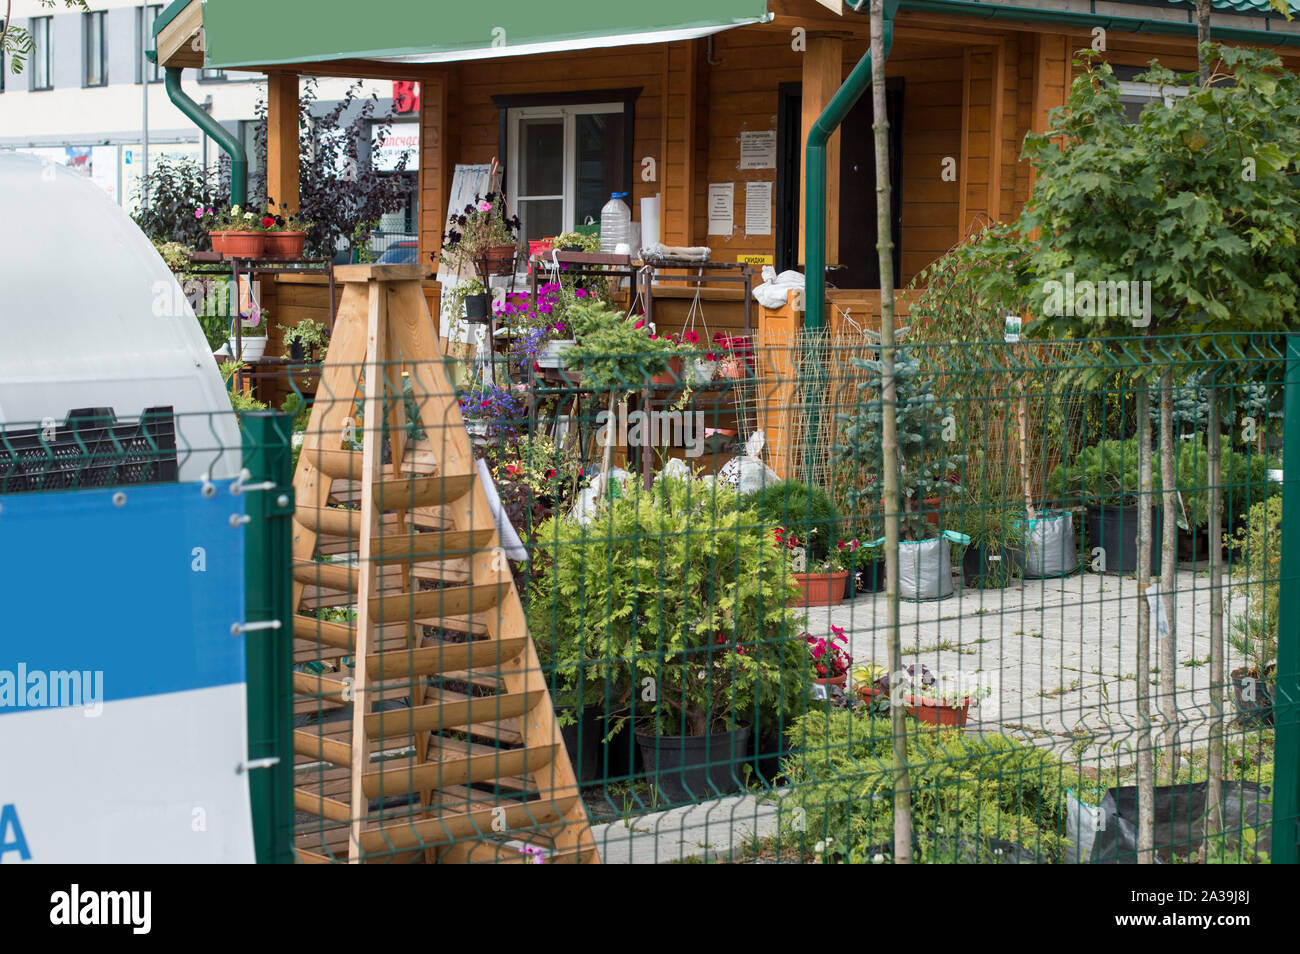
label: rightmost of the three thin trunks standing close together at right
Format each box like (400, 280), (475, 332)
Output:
(1200, 381), (1225, 863)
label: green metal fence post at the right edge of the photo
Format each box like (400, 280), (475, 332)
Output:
(1271, 334), (1300, 864)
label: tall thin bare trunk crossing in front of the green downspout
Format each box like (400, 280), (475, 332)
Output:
(871, 0), (911, 864)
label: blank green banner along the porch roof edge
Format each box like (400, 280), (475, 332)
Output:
(203, 0), (770, 69)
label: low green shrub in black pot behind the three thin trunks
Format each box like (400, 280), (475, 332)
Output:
(1047, 434), (1281, 528)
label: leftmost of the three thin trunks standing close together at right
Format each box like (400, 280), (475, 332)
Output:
(1136, 381), (1156, 864)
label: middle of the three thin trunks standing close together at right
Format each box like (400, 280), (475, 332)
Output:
(1160, 368), (1179, 785)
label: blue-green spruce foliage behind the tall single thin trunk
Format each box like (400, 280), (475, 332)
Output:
(835, 347), (966, 539)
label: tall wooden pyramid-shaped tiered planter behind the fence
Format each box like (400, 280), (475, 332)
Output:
(293, 265), (599, 863)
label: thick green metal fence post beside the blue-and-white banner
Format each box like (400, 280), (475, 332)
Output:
(241, 411), (294, 864)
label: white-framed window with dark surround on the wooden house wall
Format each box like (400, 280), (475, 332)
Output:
(506, 101), (628, 240)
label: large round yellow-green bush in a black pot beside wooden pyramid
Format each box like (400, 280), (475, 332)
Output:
(528, 478), (807, 736)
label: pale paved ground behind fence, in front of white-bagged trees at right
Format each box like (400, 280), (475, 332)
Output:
(809, 569), (1244, 762)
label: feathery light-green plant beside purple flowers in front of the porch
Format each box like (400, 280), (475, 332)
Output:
(566, 302), (676, 393)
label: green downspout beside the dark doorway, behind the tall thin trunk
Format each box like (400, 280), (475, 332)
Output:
(803, 0), (898, 331)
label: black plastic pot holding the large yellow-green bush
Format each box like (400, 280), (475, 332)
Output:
(637, 725), (753, 805)
